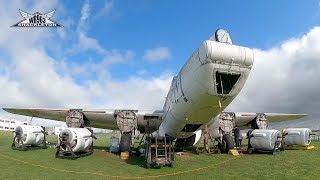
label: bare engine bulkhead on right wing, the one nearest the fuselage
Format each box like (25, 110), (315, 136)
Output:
(219, 112), (235, 134)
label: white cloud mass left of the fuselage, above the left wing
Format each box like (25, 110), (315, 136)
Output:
(0, 2), (172, 118)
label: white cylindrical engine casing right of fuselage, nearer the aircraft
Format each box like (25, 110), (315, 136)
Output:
(250, 129), (281, 151)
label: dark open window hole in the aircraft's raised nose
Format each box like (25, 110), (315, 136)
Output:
(216, 71), (240, 94)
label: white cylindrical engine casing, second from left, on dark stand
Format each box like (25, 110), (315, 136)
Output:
(59, 128), (92, 152)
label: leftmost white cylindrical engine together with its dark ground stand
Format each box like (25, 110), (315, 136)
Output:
(11, 125), (46, 151)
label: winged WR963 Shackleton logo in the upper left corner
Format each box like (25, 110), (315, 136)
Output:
(11, 9), (63, 27)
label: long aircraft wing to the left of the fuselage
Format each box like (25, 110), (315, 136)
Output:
(3, 108), (162, 131)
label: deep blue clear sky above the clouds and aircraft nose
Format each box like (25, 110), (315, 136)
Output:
(47, 1), (320, 82)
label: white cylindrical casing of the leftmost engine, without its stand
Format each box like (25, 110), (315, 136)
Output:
(14, 125), (44, 145)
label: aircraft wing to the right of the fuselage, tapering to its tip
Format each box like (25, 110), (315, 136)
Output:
(235, 112), (307, 126)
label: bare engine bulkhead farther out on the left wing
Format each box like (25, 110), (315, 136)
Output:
(66, 109), (85, 128)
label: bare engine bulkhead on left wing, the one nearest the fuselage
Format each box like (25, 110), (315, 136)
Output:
(115, 110), (137, 133)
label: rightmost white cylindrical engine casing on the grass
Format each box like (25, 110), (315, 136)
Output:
(284, 128), (312, 146)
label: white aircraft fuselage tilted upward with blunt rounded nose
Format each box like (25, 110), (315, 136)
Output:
(159, 40), (253, 138)
